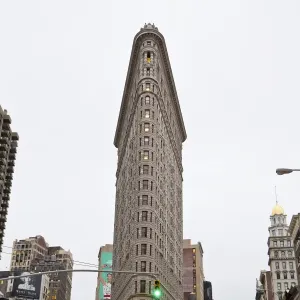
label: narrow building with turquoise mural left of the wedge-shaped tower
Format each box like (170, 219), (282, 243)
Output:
(96, 244), (113, 300)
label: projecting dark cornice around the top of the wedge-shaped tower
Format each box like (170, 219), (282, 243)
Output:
(114, 28), (186, 148)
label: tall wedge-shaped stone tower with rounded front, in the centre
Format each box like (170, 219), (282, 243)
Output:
(112, 24), (186, 300)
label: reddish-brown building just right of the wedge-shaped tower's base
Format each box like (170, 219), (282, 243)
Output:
(183, 240), (204, 300)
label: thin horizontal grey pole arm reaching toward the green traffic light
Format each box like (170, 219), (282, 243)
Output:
(0, 269), (158, 281)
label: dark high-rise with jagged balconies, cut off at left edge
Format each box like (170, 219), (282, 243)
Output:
(0, 106), (19, 254)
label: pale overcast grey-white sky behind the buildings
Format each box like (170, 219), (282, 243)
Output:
(0, 0), (300, 300)
